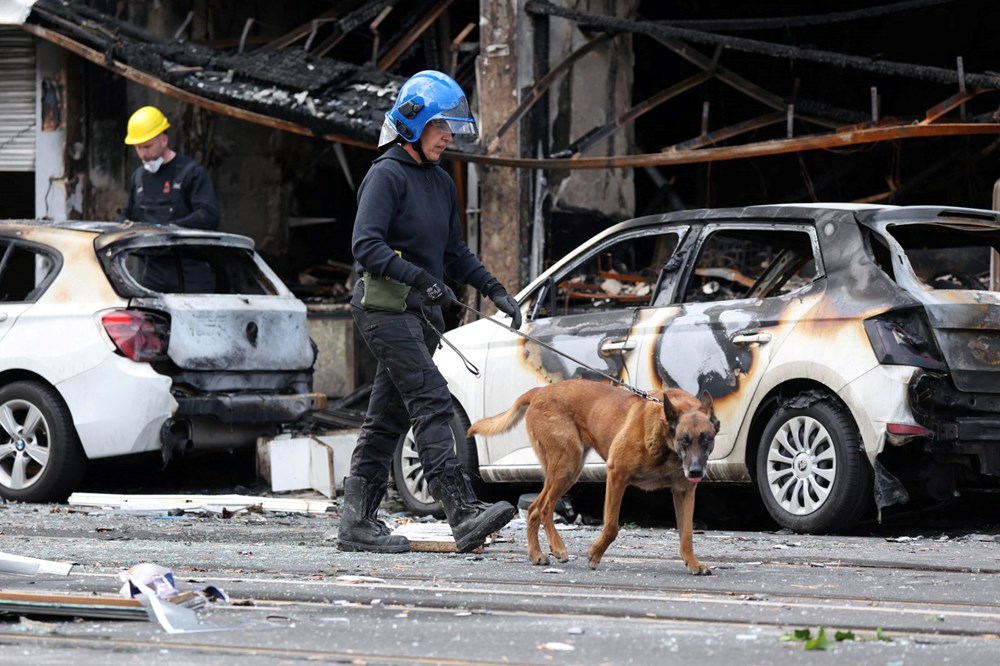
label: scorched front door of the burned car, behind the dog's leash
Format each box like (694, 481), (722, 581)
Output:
(479, 225), (687, 480)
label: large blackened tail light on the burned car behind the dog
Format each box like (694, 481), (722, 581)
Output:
(865, 309), (948, 370)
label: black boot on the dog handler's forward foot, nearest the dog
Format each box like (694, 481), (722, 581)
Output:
(427, 467), (516, 553)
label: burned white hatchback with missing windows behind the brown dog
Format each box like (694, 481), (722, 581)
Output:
(396, 204), (1000, 532)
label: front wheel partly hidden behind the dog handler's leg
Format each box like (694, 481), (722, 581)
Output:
(392, 405), (485, 518)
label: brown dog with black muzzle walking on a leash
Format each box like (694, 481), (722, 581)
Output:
(469, 379), (719, 575)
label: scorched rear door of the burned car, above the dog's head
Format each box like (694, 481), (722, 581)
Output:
(639, 221), (822, 459)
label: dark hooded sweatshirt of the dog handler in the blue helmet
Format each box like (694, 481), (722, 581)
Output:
(351, 145), (493, 311)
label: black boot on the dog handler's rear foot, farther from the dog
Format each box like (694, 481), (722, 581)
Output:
(337, 476), (410, 553)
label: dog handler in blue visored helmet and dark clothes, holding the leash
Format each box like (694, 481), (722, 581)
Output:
(337, 71), (521, 553)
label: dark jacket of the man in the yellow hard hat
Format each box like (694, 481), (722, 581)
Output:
(118, 155), (219, 229)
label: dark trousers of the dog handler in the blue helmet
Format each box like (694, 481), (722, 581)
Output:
(351, 306), (459, 485)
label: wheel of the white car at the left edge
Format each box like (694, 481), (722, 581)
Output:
(0, 381), (87, 502)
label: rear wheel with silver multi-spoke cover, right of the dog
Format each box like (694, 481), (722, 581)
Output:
(756, 398), (873, 534)
